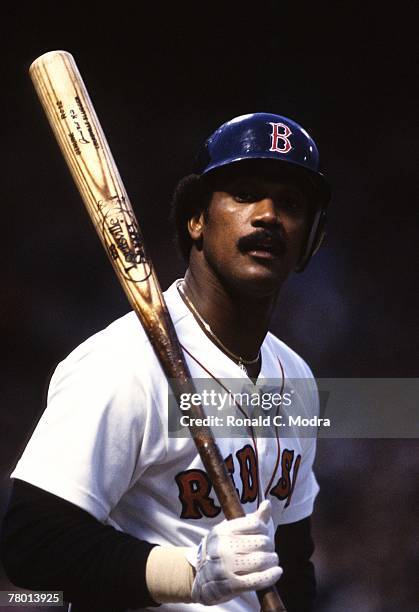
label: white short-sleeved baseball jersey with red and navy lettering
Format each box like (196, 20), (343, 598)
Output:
(12, 283), (318, 612)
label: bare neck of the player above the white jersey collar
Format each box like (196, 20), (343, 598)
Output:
(183, 268), (276, 360)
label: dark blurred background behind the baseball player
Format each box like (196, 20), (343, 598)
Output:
(0, 1), (419, 612)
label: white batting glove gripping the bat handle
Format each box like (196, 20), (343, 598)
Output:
(188, 500), (282, 606)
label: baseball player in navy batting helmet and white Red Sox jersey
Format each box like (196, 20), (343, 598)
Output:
(3, 113), (329, 612)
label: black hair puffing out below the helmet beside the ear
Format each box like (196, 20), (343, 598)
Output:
(170, 174), (212, 262)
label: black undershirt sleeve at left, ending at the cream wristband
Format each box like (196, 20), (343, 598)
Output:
(1, 479), (158, 612)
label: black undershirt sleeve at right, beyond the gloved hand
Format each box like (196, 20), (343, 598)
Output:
(275, 517), (316, 612)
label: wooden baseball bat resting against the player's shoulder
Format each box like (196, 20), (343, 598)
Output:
(29, 51), (285, 612)
